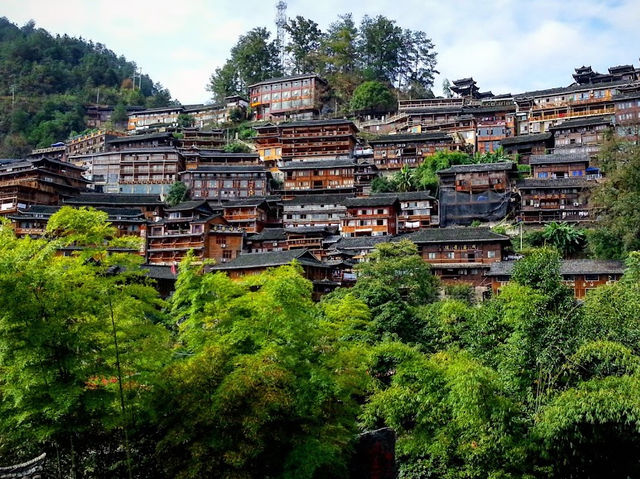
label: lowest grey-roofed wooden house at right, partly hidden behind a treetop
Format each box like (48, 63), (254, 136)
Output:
(486, 259), (624, 299)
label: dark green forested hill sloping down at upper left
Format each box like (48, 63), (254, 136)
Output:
(0, 17), (172, 158)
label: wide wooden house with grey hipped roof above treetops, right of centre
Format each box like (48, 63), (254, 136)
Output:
(402, 227), (511, 287)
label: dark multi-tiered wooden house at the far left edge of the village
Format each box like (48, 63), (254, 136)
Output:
(0, 158), (89, 215)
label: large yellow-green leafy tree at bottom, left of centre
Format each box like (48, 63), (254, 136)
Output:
(156, 265), (368, 478)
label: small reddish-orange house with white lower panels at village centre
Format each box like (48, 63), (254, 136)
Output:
(340, 195), (400, 236)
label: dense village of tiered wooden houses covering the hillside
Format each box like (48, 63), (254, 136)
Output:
(0, 61), (640, 298)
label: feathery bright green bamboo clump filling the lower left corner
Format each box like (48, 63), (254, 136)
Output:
(0, 207), (169, 477)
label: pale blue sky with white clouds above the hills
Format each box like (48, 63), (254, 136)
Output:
(5, 0), (640, 103)
